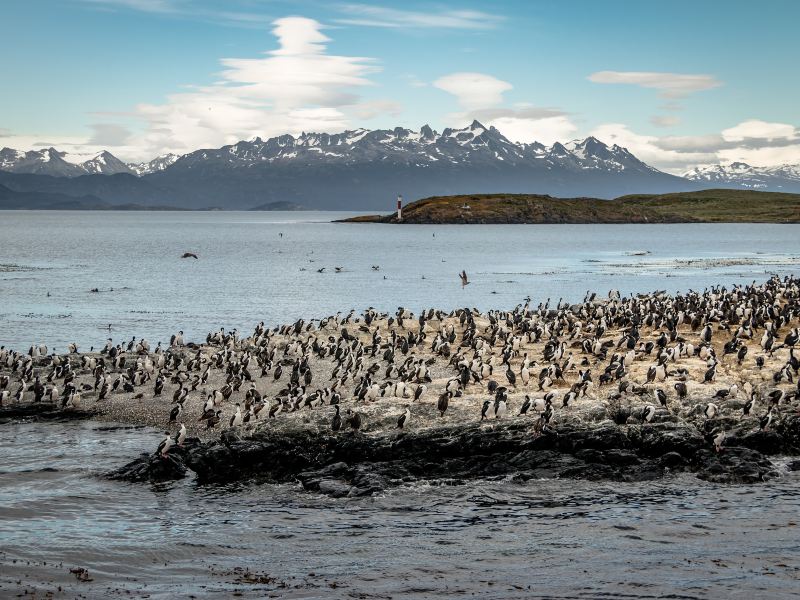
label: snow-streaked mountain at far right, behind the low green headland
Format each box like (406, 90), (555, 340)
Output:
(683, 162), (800, 193)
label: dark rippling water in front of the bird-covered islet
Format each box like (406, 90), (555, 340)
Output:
(0, 423), (800, 599)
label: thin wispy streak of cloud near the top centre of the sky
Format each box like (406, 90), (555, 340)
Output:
(335, 4), (502, 29)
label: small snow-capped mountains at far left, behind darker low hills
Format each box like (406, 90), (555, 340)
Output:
(0, 148), (133, 177)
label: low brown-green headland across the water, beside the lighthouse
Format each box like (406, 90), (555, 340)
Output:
(341, 189), (800, 225)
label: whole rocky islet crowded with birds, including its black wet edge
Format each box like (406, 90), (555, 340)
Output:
(0, 278), (800, 496)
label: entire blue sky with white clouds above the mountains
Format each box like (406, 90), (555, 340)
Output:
(0, 0), (800, 173)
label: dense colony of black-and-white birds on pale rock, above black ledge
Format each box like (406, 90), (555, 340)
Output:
(0, 277), (800, 456)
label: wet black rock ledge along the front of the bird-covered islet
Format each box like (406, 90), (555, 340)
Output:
(109, 420), (795, 497)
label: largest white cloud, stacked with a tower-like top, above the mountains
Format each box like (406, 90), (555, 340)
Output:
(122, 17), (384, 158)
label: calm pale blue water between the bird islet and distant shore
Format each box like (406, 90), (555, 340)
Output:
(0, 211), (800, 351)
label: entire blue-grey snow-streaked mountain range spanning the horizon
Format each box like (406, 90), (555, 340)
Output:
(0, 121), (800, 211)
